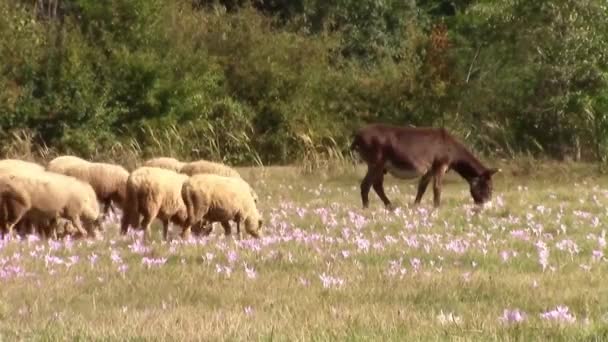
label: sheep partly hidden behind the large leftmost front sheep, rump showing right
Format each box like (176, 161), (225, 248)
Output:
(47, 156), (129, 215)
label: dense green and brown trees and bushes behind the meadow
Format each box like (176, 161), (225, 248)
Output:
(0, 0), (608, 165)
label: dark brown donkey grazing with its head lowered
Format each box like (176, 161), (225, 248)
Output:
(350, 124), (499, 208)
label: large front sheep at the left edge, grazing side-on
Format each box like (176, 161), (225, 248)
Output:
(0, 172), (100, 240)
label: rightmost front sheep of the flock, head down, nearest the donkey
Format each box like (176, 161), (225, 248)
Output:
(182, 174), (263, 238)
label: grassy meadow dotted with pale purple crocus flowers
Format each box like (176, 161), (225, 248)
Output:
(0, 168), (608, 341)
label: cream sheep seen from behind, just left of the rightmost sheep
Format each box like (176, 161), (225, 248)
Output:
(120, 166), (190, 240)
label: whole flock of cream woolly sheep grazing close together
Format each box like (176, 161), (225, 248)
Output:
(0, 156), (262, 240)
